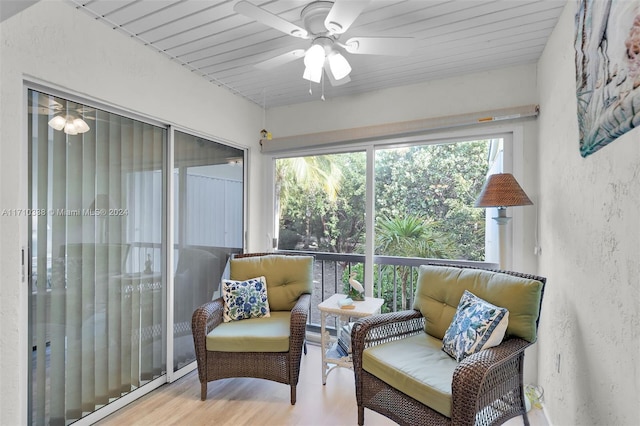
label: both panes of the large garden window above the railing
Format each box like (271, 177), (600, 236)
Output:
(275, 139), (502, 261)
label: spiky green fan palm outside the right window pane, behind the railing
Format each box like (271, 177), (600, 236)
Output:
(375, 215), (455, 309)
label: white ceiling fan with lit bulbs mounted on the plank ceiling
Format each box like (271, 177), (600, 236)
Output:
(234, 0), (415, 86)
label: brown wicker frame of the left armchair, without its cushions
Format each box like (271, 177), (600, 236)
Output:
(191, 253), (311, 405)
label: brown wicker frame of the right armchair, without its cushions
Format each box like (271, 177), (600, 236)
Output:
(351, 266), (546, 426)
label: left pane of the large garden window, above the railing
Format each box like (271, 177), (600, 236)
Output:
(275, 152), (366, 254)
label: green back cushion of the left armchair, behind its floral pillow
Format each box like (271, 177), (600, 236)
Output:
(230, 255), (313, 311)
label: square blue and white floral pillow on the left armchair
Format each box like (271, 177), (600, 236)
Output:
(222, 277), (271, 322)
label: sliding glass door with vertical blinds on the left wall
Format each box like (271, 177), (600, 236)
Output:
(26, 90), (244, 425)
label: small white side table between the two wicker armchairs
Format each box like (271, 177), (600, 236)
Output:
(318, 293), (384, 385)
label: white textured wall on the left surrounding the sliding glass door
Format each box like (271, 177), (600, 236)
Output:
(0, 1), (262, 425)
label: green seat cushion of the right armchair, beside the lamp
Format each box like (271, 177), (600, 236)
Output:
(362, 333), (458, 417)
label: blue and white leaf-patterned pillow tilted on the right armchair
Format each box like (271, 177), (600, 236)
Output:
(442, 290), (509, 362)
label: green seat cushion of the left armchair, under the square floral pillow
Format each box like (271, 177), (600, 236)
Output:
(207, 311), (291, 352)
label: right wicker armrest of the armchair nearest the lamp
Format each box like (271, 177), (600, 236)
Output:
(451, 338), (531, 425)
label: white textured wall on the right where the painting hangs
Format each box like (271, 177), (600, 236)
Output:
(538, 0), (640, 426)
